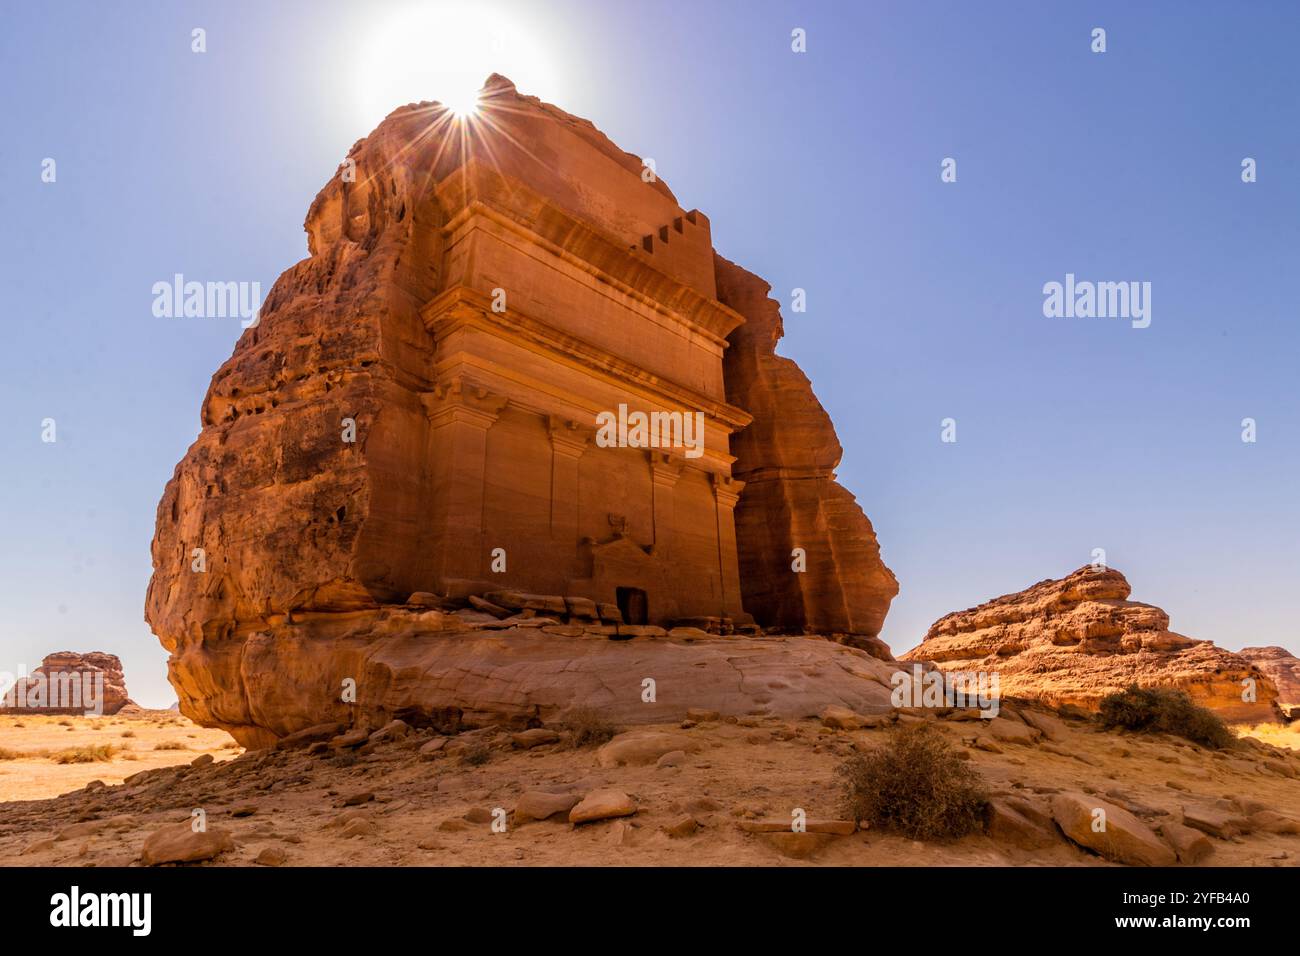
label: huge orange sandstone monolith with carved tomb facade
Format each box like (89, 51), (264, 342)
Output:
(146, 77), (897, 743)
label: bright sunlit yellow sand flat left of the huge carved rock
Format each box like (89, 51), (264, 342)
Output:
(0, 710), (243, 803)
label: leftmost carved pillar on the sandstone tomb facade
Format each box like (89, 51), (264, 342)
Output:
(423, 376), (507, 580)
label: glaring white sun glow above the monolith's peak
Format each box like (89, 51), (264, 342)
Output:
(355, 0), (563, 125)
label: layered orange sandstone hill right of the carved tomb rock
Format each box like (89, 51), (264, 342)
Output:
(900, 566), (1278, 722)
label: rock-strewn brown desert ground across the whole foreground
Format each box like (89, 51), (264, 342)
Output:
(0, 706), (1300, 866)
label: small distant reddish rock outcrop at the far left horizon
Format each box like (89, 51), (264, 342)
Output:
(0, 650), (133, 714)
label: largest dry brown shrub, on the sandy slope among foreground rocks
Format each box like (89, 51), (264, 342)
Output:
(836, 723), (988, 840)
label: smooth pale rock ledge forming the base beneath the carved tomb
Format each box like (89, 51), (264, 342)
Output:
(169, 607), (897, 756)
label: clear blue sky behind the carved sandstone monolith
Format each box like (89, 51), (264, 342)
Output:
(0, 0), (1300, 705)
